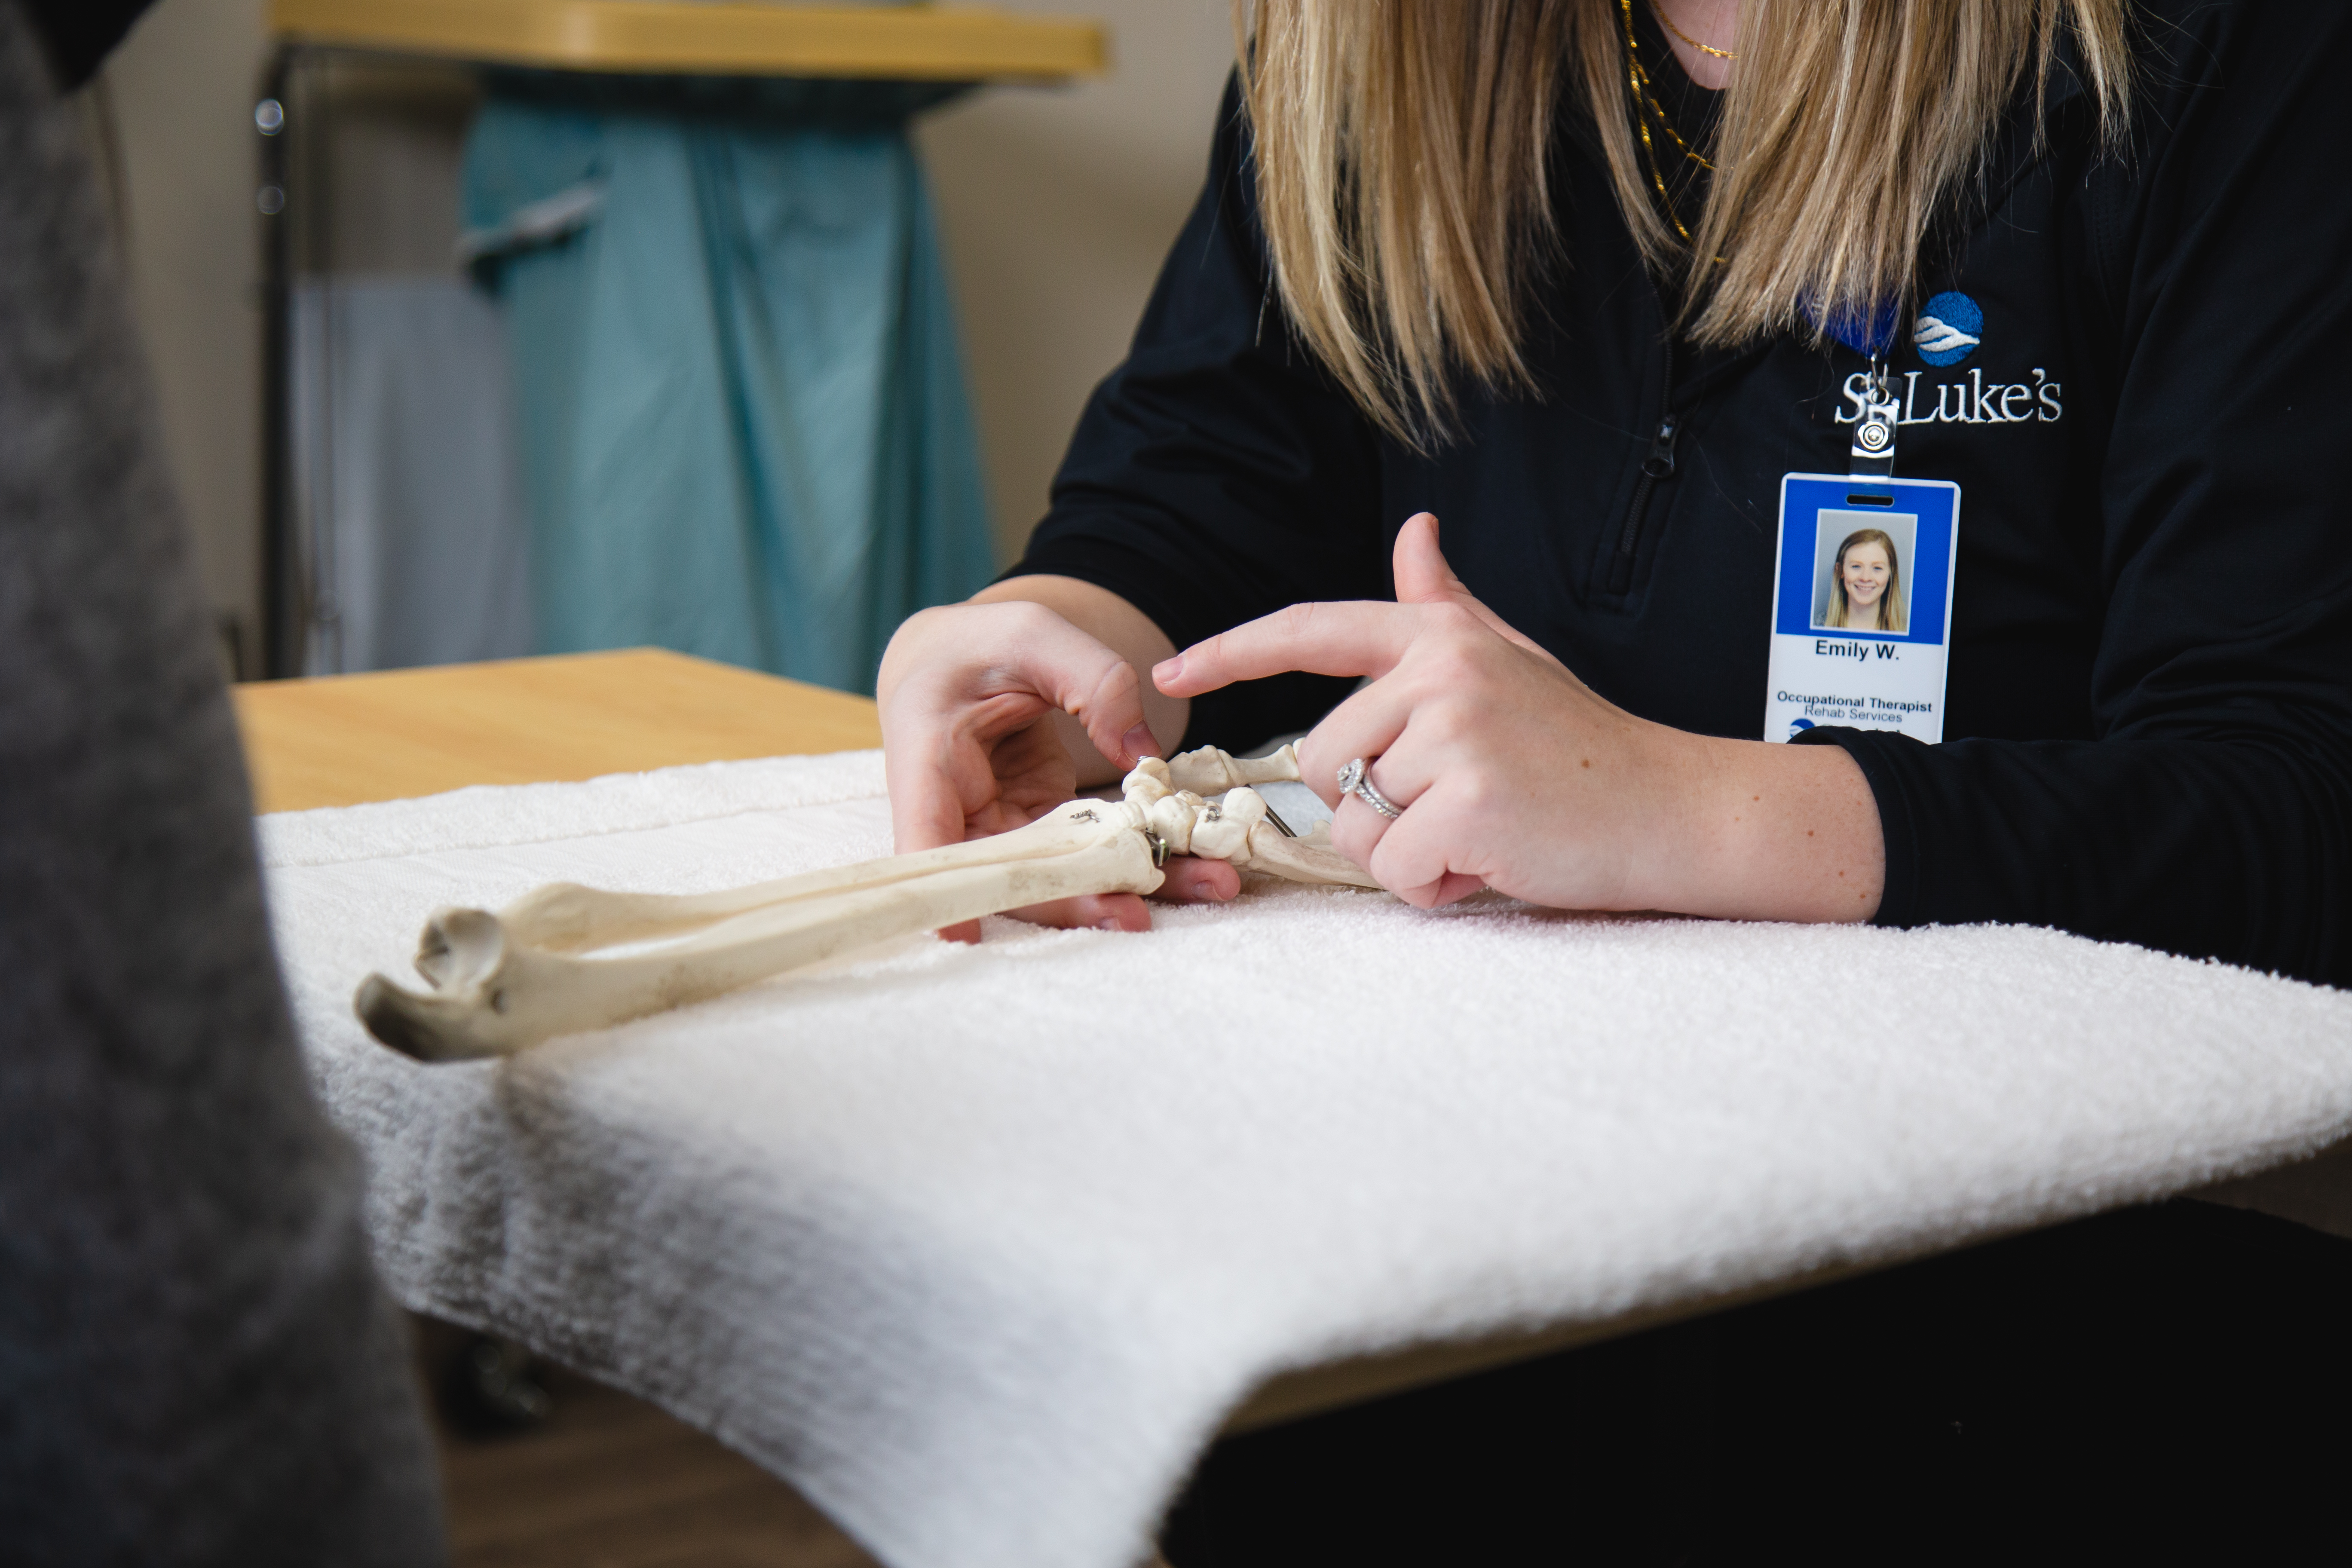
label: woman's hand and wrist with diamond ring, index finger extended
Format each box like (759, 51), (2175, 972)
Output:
(1152, 512), (1884, 919)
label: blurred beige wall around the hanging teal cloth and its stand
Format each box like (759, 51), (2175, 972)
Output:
(92, 0), (1232, 672)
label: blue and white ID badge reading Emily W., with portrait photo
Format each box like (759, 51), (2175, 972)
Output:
(1764, 472), (1959, 743)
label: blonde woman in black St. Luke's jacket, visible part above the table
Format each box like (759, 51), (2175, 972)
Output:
(880, 0), (2352, 983)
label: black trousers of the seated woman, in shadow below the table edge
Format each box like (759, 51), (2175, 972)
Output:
(1164, 1201), (2352, 1568)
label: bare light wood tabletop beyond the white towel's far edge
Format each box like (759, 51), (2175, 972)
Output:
(230, 649), (882, 811)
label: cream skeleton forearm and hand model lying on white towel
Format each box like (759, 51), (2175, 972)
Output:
(355, 745), (1378, 1063)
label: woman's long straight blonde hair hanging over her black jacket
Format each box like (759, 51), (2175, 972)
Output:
(1232, 0), (2131, 447)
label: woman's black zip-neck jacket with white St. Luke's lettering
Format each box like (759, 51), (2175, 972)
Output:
(1014, 0), (2352, 985)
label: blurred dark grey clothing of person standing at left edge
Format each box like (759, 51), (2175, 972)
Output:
(0, 0), (444, 1568)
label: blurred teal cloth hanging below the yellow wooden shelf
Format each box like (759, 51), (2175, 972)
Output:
(463, 75), (992, 691)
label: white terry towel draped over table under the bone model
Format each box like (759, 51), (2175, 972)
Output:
(261, 755), (2352, 1568)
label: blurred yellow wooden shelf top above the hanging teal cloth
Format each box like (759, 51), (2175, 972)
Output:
(270, 0), (1106, 82)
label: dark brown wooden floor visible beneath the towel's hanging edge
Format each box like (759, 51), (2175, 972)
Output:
(442, 1368), (875, 1568)
